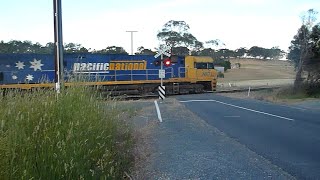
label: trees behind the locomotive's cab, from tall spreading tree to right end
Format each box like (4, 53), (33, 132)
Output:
(155, 20), (285, 59)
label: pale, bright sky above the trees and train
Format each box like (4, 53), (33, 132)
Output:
(0, 0), (320, 53)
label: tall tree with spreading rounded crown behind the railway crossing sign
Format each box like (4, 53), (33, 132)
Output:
(157, 20), (203, 53)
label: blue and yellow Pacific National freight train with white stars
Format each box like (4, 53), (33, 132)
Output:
(0, 53), (217, 95)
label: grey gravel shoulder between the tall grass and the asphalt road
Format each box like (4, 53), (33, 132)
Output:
(132, 98), (294, 179)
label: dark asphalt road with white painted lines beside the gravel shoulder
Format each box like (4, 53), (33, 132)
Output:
(178, 94), (320, 179)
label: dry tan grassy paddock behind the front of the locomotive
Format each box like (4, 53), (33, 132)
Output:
(219, 59), (295, 83)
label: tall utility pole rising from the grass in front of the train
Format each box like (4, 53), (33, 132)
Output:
(53, 0), (64, 93)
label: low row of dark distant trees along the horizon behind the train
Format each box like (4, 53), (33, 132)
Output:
(0, 40), (284, 59)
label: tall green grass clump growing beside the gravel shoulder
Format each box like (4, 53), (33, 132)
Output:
(0, 87), (133, 179)
